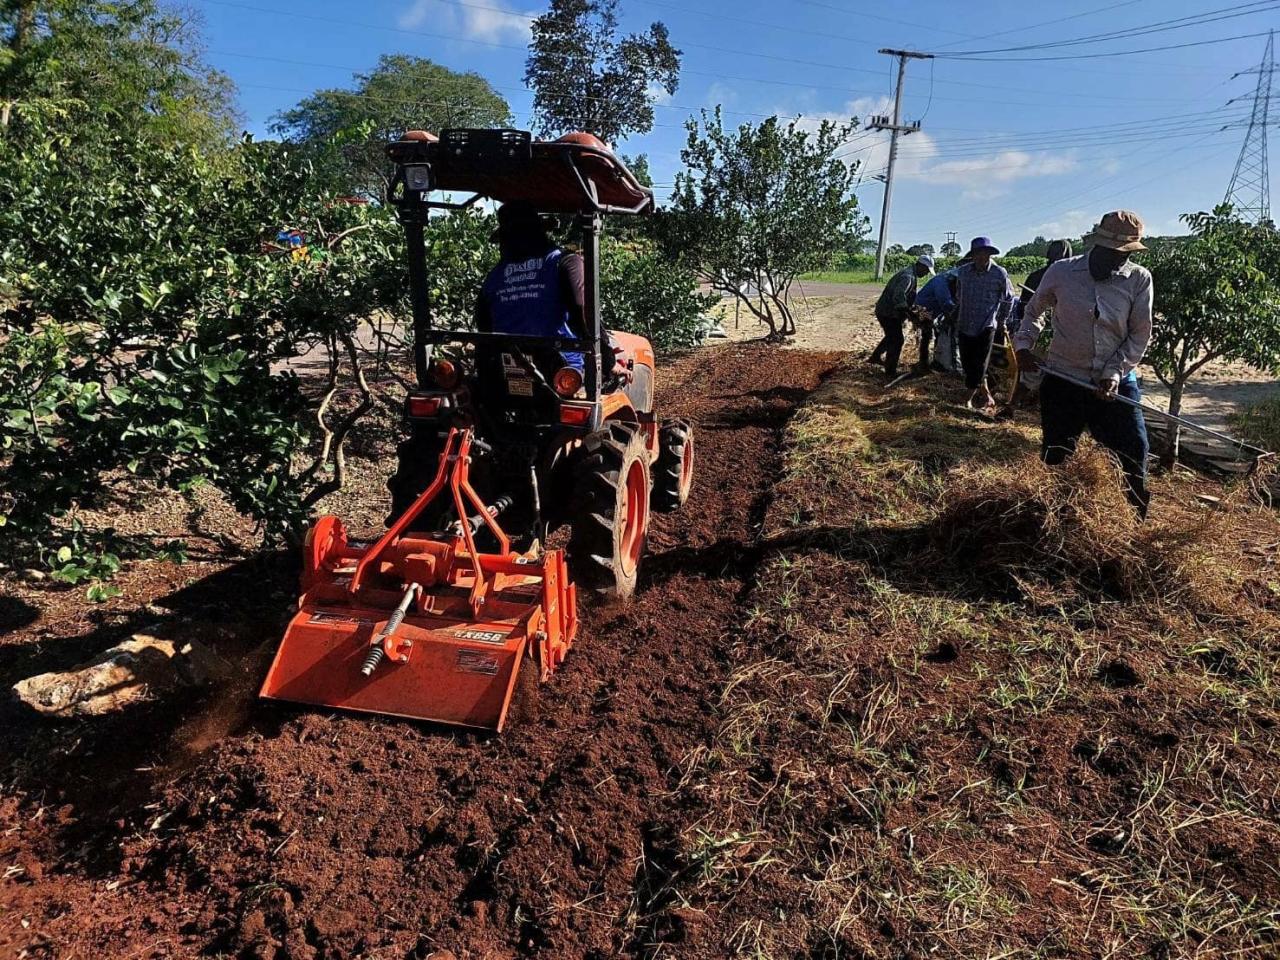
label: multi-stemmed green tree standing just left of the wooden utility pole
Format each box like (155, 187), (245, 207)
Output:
(666, 110), (867, 339)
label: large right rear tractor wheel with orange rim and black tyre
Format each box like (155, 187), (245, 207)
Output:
(568, 424), (652, 600)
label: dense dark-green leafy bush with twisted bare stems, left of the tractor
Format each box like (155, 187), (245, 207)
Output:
(0, 101), (506, 570)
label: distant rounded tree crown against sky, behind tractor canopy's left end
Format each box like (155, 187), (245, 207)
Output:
(271, 54), (511, 198)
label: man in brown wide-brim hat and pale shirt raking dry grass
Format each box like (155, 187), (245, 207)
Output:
(1014, 210), (1153, 517)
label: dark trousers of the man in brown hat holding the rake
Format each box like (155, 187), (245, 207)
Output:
(1041, 374), (1151, 517)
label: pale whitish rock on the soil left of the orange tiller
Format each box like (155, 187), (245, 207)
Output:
(13, 634), (228, 717)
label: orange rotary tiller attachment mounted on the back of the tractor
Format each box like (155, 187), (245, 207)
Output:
(261, 429), (577, 731)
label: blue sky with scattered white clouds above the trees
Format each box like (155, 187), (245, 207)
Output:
(191, 0), (1280, 246)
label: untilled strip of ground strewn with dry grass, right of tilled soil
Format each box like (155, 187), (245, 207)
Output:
(650, 358), (1280, 957)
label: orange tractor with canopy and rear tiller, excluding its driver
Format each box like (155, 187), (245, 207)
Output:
(261, 129), (694, 731)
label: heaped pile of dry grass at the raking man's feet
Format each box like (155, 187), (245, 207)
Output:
(927, 447), (1234, 609)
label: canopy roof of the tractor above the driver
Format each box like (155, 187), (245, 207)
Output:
(387, 129), (653, 214)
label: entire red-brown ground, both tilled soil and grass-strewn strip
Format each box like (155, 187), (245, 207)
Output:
(0, 313), (1280, 960)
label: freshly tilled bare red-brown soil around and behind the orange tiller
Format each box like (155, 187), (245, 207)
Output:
(0, 347), (837, 960)
